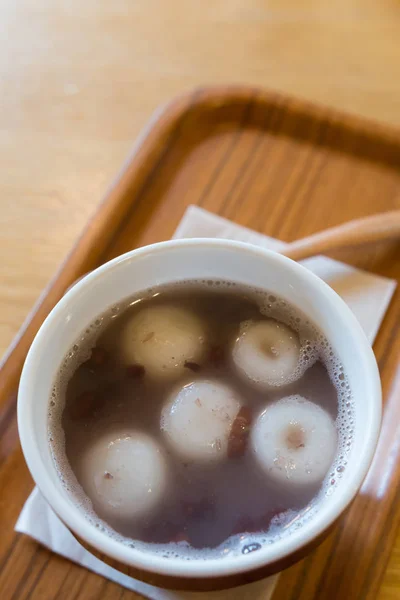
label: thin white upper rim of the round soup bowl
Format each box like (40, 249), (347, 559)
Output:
(18, 238), (382, 578)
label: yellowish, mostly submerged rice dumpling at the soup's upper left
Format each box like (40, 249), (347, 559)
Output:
(121, 305), (205, 379)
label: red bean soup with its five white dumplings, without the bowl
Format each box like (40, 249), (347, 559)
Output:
(48, 280), (354, 558)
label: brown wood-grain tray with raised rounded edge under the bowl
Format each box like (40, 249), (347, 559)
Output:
(0, 87), (400, 600)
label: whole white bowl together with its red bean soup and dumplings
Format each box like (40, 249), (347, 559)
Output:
(18, 239), (381, 589)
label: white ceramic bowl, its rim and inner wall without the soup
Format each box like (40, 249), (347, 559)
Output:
(18, 239), (381, 579)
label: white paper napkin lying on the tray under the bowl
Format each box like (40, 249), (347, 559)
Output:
(15, 206), (396, 600)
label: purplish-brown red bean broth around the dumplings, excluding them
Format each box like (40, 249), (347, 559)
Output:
(50, 283), (350, 552)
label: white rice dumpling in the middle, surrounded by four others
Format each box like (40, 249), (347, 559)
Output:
(161, 380), (241, 462)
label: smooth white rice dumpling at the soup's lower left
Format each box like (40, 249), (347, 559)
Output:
(80, 432), (167, 519)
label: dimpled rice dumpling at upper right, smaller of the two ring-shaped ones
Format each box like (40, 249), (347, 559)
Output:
(232, 319), (301, 389)
